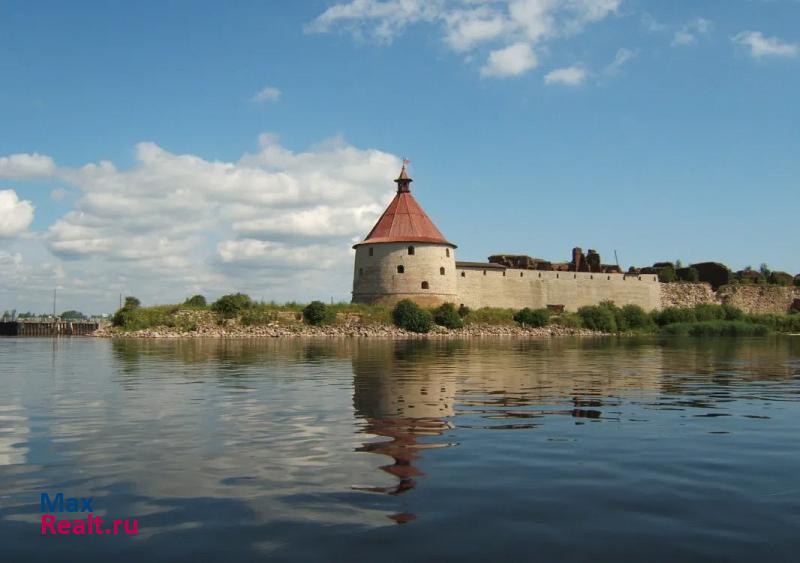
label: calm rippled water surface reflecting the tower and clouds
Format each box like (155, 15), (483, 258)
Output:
(0, 337), (800, 562)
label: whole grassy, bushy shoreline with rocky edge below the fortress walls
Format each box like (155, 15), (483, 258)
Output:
(104, 294), (800, 337)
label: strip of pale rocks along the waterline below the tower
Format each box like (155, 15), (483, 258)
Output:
(92, 323), (607, 339)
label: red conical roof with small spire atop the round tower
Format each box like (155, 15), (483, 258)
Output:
(353, 165), (456, 248)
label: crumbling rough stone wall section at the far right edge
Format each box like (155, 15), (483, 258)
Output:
(661, 283), (800, 314)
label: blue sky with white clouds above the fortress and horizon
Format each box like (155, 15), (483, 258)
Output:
(0, 0), (800, 311)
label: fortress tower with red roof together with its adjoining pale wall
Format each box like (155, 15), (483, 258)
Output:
(353, 165), (661, 311)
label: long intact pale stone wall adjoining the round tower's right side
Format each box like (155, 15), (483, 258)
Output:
(456, 268), (661, 311)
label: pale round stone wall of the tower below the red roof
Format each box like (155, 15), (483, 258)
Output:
(353, 242), (458, 307)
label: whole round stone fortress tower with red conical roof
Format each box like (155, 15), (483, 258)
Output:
(353, 164), (458, 306)
